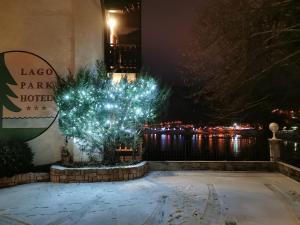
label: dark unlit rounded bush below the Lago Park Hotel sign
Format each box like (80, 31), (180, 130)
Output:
(0, 141), (33, 177)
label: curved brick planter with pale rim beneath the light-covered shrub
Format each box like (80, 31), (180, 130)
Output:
(50, 162), (148, 183)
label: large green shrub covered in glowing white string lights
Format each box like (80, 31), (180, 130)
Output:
(55, 62), (170, 164)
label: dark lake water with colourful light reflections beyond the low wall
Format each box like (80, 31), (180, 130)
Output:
(144, 134), (269, 161)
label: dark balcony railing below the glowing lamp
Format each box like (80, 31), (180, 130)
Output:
(105, 44), (141, 73)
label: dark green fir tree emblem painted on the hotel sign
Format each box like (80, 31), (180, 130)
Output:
(0, 53), (21, 128)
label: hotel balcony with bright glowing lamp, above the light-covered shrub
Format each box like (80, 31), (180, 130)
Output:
(103, 0), (141, 74)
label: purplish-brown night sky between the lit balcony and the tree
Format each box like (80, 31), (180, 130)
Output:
(142, 0), (202, 86)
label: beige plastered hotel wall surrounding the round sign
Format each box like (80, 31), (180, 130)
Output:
(0, 0), (104, 165)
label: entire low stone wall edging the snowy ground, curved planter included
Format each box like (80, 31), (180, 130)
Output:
(0, 161), (300, 188)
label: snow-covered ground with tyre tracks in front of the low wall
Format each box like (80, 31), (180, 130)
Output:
(0, 171), (300, 225)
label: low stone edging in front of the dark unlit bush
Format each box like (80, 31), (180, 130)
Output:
(0, 173), (50, 188)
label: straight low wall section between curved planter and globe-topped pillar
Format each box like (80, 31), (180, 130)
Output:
(148, 161), (276, 172)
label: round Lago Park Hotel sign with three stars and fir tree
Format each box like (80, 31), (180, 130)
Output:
(0, 51), (57, 140)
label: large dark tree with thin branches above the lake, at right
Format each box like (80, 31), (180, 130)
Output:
(182, 0), (300, 123)
